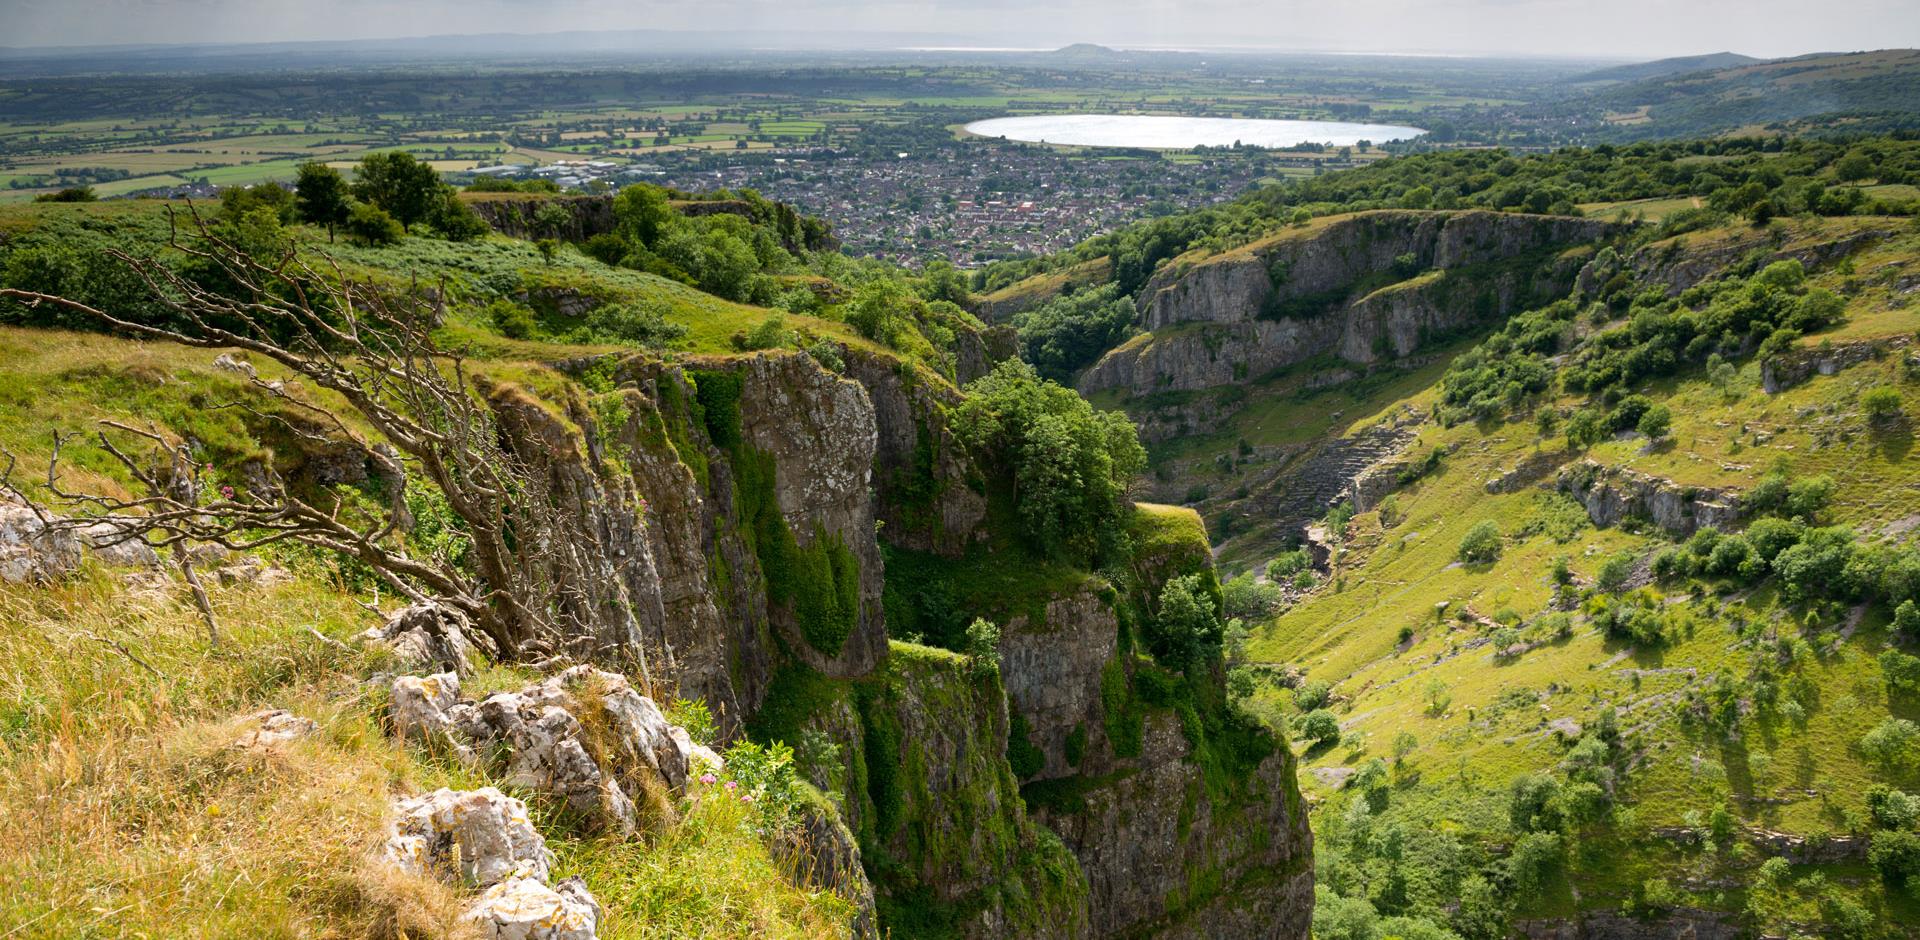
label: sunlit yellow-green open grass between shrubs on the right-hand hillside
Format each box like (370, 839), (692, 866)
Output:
(1228, 218), (1920, 923)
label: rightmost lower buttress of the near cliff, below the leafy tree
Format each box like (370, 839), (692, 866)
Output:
(1000, 520), (1313, 938)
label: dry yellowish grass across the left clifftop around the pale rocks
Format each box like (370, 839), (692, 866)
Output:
(0, 242), (864, 938)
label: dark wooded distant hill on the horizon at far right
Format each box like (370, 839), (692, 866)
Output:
(1594, 50), (1920, 140)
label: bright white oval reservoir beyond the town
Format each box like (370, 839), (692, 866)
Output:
(966, 115), (1427, 150)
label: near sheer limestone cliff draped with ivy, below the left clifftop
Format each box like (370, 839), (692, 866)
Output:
(509, 351), (1311, 936)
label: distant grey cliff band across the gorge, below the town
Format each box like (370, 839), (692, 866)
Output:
(1079, 211), (1613, 395)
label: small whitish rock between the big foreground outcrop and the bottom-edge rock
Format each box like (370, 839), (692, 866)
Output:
(380, 787), (553, 886)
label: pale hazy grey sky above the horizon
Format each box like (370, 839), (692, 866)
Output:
(0, 0), (1920, 58)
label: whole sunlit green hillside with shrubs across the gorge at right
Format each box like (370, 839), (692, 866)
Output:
(1117, 209), (1920, 936)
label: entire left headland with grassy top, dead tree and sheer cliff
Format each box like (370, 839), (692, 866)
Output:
(0, 180), (1311, 938)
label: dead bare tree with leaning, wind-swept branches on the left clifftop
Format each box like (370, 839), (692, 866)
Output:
(0, 209), (649, 673)
